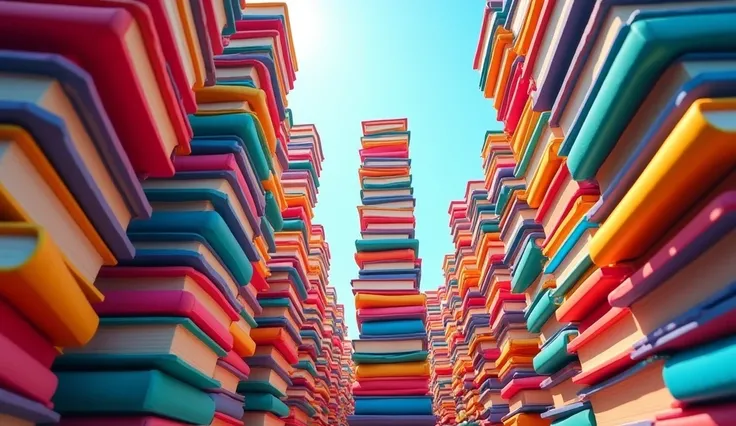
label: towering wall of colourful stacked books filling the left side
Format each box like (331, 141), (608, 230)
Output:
(0, 0), (350, 426)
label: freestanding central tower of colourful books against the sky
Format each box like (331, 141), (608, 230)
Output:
(349, 119), (435, 426)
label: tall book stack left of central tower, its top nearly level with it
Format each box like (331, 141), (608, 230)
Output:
(242, 113), (322, 424)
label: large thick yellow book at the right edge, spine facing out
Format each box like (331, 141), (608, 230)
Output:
(590, 98), (736, 266)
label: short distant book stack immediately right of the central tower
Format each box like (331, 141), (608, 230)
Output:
(427, 286), (455, 424)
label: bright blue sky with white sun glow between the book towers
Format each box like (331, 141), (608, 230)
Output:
(287, 0), (499, 338)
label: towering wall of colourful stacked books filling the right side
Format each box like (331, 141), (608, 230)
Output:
(460, 0), (736, 426)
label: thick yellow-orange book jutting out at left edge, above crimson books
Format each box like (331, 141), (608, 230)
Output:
(0, 222), (99, 347)
